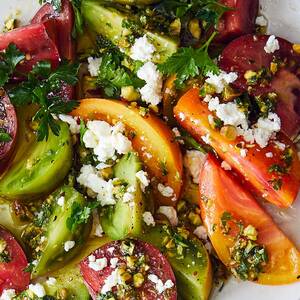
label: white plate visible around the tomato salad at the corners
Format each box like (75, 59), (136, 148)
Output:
(0, 0), (300, 300)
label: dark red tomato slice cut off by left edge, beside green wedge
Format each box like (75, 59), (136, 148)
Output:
(0, 94), (18, 171)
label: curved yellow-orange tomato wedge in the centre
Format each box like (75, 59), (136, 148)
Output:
(71, 98), (183, 206)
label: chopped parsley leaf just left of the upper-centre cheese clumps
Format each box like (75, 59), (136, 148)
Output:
(97, 52), (145, 97)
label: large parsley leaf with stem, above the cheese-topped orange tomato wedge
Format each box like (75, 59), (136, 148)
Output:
(158, 33), (219, 88)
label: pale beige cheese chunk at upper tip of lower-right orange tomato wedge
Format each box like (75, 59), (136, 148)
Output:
(183, 150), (206, 184)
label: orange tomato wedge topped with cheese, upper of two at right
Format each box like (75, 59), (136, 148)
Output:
(174, 89), (300, 207)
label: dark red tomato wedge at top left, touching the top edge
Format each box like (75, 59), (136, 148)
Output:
(31, 0), (75, 60)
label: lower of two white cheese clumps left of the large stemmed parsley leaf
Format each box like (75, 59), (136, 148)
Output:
(137, 62), (163, 106)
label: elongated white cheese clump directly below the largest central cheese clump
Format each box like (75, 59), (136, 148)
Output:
(77, 165), (116, 206)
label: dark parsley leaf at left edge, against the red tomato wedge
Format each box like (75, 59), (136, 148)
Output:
(0, 44), (25, 87)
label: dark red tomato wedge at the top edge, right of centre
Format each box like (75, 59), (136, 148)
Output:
(216, 0), (259, 42)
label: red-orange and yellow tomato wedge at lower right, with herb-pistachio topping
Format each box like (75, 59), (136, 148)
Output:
(199, 156), (300, 285)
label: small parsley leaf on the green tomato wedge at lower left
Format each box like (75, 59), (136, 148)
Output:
(66, 201), (100, 232)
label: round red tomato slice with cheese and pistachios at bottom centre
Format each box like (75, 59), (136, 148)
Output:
(80, 240), (177, 300)
